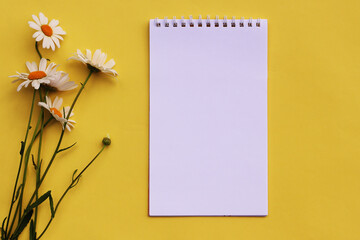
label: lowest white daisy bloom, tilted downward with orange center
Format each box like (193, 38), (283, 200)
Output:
(38, 96), (76, 132)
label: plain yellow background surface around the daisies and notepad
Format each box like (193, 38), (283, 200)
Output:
(0, 0), (360, 240)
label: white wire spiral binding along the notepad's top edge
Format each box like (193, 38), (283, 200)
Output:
(154, 15), (261, 27)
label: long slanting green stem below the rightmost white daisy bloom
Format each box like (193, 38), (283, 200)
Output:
(26, 70), (93, 212)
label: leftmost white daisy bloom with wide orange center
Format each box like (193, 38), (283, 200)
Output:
(9, 58), (57, 91)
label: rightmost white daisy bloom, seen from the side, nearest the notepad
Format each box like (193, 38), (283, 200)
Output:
(69, 49), (118, 77)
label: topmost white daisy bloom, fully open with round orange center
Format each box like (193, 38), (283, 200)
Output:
(28, 13), (66, 51)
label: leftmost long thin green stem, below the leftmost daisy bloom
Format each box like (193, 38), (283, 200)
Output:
(5, 89), (36, 235)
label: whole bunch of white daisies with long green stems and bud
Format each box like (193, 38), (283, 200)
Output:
(0, 13), (117, 240)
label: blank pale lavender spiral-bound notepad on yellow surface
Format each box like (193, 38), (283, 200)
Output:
(149, 18), (268, 216)
